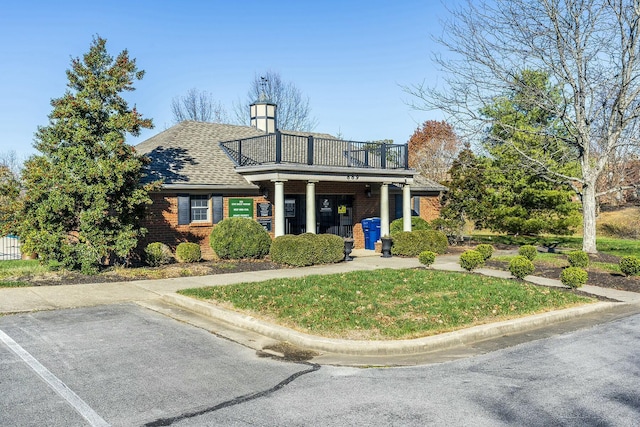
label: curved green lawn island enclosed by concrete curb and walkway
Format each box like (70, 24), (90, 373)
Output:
(180, 269), (593, 339)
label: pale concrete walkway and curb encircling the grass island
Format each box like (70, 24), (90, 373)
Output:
(0, 250), (640, 364)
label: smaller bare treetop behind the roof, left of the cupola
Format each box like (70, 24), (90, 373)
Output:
(171, 88), (227, 123)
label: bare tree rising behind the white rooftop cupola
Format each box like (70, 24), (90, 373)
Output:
(234, 71), (317, 131)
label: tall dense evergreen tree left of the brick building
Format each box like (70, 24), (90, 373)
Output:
(19, 37), (155, 272)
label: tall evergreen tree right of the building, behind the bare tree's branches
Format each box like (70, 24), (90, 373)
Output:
(482, 70), (580, 234)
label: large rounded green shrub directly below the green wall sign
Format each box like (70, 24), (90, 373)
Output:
(209, 218), (271, 259)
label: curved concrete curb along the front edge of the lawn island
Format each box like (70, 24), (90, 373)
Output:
(162, 294), (624, 356)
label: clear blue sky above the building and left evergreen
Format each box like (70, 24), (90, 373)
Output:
(0, 0), (451, 158)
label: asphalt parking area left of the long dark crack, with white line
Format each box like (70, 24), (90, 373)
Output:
(0, 304), (309, 426)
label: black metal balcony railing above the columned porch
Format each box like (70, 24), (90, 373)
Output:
(220, 131), (409, 169)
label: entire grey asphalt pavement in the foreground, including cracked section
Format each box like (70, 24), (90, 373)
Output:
(0, 303), (640, 427)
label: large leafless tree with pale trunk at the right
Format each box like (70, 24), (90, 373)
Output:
(405, 0), (640, 253)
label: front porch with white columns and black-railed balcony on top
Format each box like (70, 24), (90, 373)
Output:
(220, 132), (416, 242)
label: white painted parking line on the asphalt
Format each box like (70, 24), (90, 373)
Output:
(0, 330), (109, 427)
